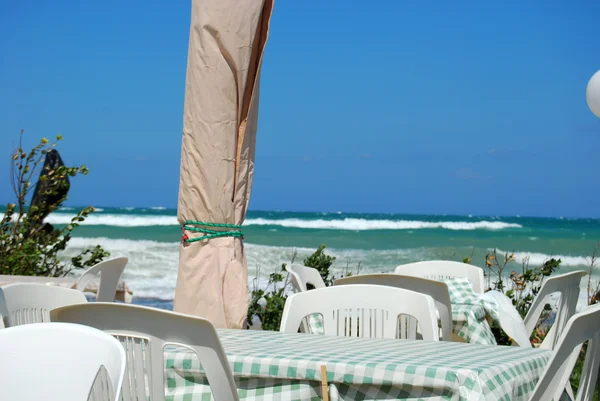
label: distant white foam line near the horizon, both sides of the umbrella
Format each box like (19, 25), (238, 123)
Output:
(47, 213), (522, 231)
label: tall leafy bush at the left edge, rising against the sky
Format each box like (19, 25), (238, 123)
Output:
(0, 132), (109, 277)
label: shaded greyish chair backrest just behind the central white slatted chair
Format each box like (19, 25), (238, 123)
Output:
(333, 273), (452, 341)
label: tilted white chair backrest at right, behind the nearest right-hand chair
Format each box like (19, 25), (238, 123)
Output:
(524, 270), (586, 349)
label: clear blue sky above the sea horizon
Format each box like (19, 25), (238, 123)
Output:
(0, 0), (600, 217)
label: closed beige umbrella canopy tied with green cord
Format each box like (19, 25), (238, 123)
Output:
(174, 0), (273, 328)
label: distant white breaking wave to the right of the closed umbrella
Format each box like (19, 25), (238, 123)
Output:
(245, 218), (523, 231)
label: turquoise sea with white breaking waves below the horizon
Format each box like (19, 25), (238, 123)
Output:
(30, 207), (600, 309)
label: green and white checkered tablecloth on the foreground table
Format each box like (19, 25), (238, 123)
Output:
(165, 329), (551, 401)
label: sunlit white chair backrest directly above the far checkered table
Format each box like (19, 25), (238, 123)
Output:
(394, 260), (485, 294)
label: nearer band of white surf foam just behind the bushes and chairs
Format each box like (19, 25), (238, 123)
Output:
(64, 237), (589, 300)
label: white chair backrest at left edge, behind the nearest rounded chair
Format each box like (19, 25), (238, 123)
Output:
(0, 284), (87, 327)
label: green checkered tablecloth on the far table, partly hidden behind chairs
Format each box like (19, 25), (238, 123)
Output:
(308, 278), (497, 345)
